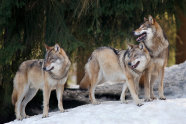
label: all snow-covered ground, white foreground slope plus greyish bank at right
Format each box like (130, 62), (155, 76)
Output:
(6, 62), (186, 124)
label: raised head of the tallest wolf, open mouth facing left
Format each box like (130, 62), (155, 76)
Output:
(134, 15), (158, 42)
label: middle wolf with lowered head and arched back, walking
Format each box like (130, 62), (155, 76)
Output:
(80, 43), (150, 106)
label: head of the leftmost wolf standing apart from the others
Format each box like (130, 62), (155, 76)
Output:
(43, 44), (66, 73)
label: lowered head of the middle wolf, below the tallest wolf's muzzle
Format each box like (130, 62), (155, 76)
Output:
(125, 43), (150, 72)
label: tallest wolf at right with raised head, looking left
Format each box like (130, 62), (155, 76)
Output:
(134, 15), (169, 101)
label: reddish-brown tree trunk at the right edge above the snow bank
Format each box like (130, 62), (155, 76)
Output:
(176, 8), (186, 64)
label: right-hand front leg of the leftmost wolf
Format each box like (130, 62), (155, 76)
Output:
(56, 84), (64, 112)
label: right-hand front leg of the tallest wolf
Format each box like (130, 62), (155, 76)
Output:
(158, 67), (166, 100)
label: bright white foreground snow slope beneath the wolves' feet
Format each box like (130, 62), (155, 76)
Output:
(8, 98), (186, 124)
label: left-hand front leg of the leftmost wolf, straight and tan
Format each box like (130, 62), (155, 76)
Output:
(43, 82), (51, 118)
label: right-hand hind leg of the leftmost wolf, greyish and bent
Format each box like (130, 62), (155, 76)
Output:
(22, 88), (38, 118)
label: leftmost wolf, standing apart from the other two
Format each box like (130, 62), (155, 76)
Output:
(12, 44), (71, 120)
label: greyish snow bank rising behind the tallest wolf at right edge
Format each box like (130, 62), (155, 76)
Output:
(164, 61), (186, 98)
